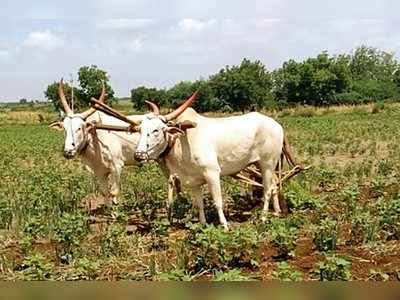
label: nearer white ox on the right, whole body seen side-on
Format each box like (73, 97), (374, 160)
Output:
(130, 94), (293, 228)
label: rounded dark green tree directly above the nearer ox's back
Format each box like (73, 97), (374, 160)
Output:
(210, 59), (272, 111)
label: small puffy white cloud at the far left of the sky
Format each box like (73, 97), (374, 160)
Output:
(23, 30), (65, 51)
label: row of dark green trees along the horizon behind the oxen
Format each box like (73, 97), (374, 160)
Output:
(45, 46), (400, 112)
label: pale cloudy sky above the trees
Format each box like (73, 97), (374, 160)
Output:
(0, 0), (400, 102)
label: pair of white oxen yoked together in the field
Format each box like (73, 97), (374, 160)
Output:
(50, 81), (293, 228)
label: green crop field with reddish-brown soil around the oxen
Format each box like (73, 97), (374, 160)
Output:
(0, 102), (400, 281)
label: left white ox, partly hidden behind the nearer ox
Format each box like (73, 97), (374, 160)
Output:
(50, 80), (141, 205)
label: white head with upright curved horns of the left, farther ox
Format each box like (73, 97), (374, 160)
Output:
(50, 79), (106, 159)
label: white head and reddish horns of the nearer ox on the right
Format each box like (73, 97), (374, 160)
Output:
(135, 92), (197, 161)
